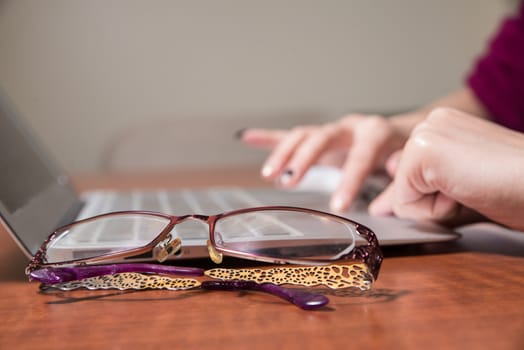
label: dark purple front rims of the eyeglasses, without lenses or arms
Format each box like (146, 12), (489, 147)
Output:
(26, 206), (383, 279)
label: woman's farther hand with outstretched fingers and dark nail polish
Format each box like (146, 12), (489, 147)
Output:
(241, 115), (409, 211)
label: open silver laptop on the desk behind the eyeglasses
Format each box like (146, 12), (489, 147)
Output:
(0, 93), (458, 260)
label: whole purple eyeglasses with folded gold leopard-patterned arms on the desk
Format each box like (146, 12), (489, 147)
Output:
(26, 206), (383, 309)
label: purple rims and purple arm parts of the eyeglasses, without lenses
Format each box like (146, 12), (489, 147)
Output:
(26, 206), (383, 310)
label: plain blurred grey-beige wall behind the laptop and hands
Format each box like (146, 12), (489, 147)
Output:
(0, 0), (515, 172)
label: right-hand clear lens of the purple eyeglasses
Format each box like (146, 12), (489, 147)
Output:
(214, 210), (355, 260)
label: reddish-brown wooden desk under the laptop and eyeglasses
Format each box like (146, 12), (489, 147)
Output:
(0, 171), (524, 350)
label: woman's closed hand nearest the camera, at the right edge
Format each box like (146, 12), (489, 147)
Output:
(370, 108), (524, 230)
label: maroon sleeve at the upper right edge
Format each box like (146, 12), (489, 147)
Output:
(467, 2), (524, 132)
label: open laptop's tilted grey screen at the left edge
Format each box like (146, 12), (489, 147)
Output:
(0, 92), (78, 255)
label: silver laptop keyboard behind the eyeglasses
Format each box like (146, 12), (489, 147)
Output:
(68, 186), (380, 246)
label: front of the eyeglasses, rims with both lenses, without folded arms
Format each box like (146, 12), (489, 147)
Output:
(26, 206), (382, 279)
